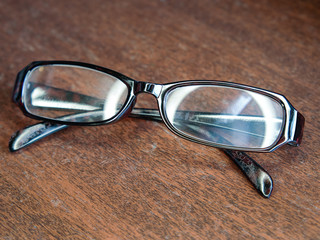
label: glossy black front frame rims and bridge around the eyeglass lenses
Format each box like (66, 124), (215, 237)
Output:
(13, 61), (304, 152)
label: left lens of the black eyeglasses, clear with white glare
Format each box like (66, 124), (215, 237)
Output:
(23, 64), (129, 123)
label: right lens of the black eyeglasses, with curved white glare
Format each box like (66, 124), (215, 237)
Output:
(164, 85), (284, 150)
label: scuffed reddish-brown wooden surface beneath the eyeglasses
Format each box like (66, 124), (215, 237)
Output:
(0, 0), (320, 239)
